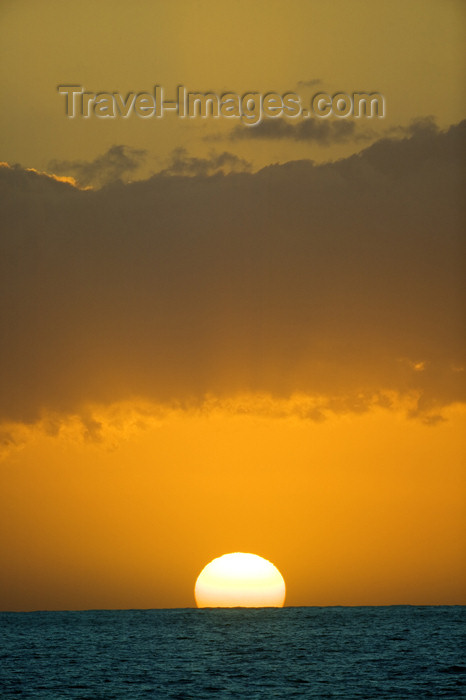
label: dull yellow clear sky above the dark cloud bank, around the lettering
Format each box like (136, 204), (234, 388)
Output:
(0, 0), (465, 175)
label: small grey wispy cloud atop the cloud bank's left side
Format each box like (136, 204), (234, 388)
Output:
(48, 145), (147, 187)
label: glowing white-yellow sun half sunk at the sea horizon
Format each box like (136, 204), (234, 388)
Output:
(194, 552), (286, 608)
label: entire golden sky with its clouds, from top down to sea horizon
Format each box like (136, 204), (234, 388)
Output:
(0, 0), (466, 610)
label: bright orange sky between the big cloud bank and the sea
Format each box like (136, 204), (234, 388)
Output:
(2, 406), (464, 609)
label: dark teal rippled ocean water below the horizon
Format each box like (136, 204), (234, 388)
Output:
(0, 606), (466, 700)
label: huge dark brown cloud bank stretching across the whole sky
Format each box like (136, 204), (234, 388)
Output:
(0, 122), (466, 424)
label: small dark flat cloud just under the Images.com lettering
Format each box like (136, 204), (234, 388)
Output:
(230, 119), (373, 146)
